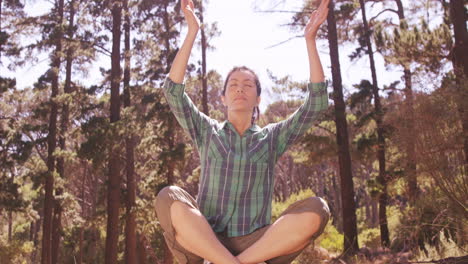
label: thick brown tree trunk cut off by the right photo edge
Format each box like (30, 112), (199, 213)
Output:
(450, 0), (468, 167)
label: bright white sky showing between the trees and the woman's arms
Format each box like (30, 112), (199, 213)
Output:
(2, 0), (401, 111)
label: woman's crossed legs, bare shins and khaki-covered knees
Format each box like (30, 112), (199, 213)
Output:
(156, 186), (329, 264)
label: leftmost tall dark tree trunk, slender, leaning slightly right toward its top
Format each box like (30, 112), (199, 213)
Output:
(41, 0), (64, 264)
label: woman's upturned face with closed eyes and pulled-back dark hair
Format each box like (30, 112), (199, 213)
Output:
(221, 70), (260, 114)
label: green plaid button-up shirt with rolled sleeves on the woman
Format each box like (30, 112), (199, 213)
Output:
(164, 78), (328, 237)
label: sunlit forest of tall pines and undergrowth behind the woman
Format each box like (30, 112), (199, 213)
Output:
(0, 0), (468, 264)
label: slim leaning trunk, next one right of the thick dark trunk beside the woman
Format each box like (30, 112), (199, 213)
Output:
(359, 0), (390, 247)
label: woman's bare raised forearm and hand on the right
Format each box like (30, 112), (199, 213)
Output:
(304, 0), (330, 83)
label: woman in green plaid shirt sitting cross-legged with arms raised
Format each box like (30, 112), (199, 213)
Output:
(155, 0), (329, 264)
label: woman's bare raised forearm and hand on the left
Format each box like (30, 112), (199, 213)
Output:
(169, 0), (200, 83)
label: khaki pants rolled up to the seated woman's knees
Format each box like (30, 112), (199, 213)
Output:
(155, 186), (330, 264)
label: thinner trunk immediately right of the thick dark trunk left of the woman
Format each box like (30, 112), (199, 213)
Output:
(123, 0), (137, 264)
